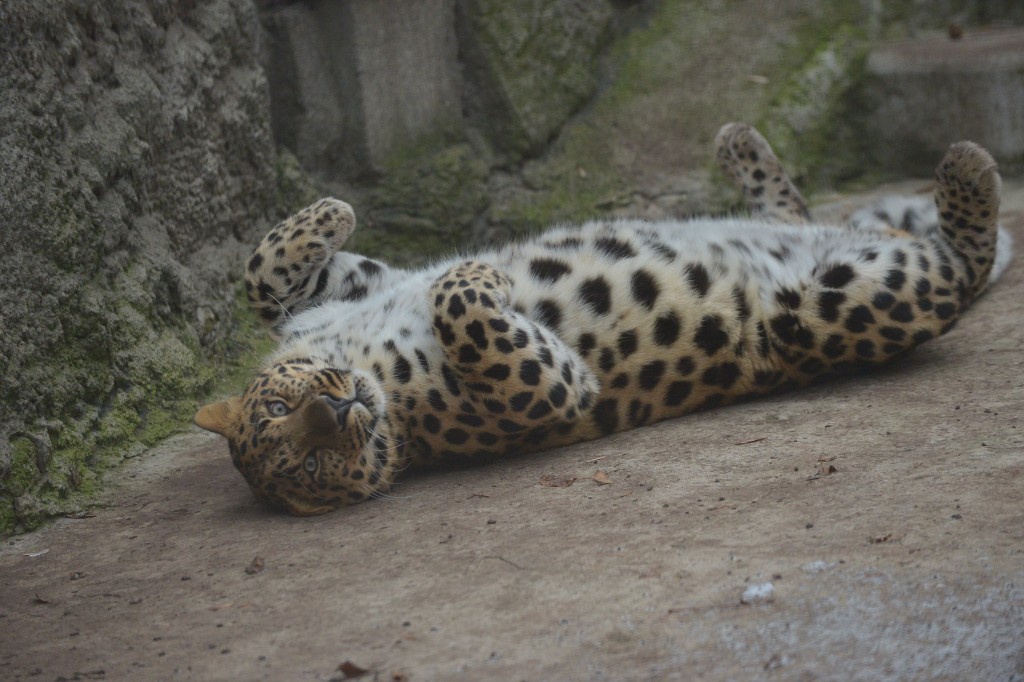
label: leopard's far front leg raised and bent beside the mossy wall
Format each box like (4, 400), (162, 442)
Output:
(246, 199), (389, 331)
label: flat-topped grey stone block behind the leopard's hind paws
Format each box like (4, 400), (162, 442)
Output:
(867, 29), (1024, 173)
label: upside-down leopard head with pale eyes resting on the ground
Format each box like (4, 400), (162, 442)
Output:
(195, 363), (396, 509)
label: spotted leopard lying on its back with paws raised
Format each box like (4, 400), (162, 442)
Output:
(194, 123), (1010, 516)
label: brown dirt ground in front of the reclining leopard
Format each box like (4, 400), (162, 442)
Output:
(6, 182), (1024, 682)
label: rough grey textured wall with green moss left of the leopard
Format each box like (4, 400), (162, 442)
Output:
(0, 0), (276, 534)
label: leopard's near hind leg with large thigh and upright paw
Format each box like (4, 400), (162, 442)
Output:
(760, 142), (1000, 387)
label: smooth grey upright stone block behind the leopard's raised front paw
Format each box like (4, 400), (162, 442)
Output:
(262, 0), (462, 177)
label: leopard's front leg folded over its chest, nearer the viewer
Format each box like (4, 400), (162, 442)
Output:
(429, 261), (598, 433)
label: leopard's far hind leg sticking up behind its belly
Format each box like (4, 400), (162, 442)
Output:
(715, 123), (811, 225)
